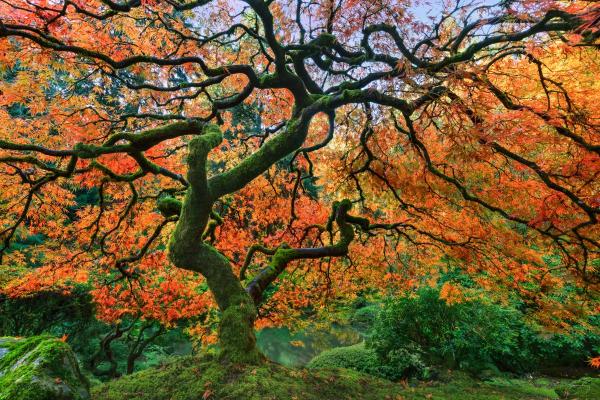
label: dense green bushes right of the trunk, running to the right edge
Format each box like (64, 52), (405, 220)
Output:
(367, 288), (600, 377)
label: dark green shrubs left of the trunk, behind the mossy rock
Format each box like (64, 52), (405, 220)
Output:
(0, 285), (191, 379)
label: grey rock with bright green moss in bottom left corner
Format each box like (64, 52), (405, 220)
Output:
(0, 336), (90, 400)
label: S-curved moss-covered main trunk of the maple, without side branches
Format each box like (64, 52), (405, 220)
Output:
(168, 125), (263, 363)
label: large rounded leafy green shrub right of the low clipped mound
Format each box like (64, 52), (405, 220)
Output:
(369, 288), (530, 376)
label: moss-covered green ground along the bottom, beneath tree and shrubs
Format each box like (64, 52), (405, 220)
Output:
(92, 357), (596, 400)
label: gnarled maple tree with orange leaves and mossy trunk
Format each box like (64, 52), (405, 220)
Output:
(0, 0), (600, 362)
